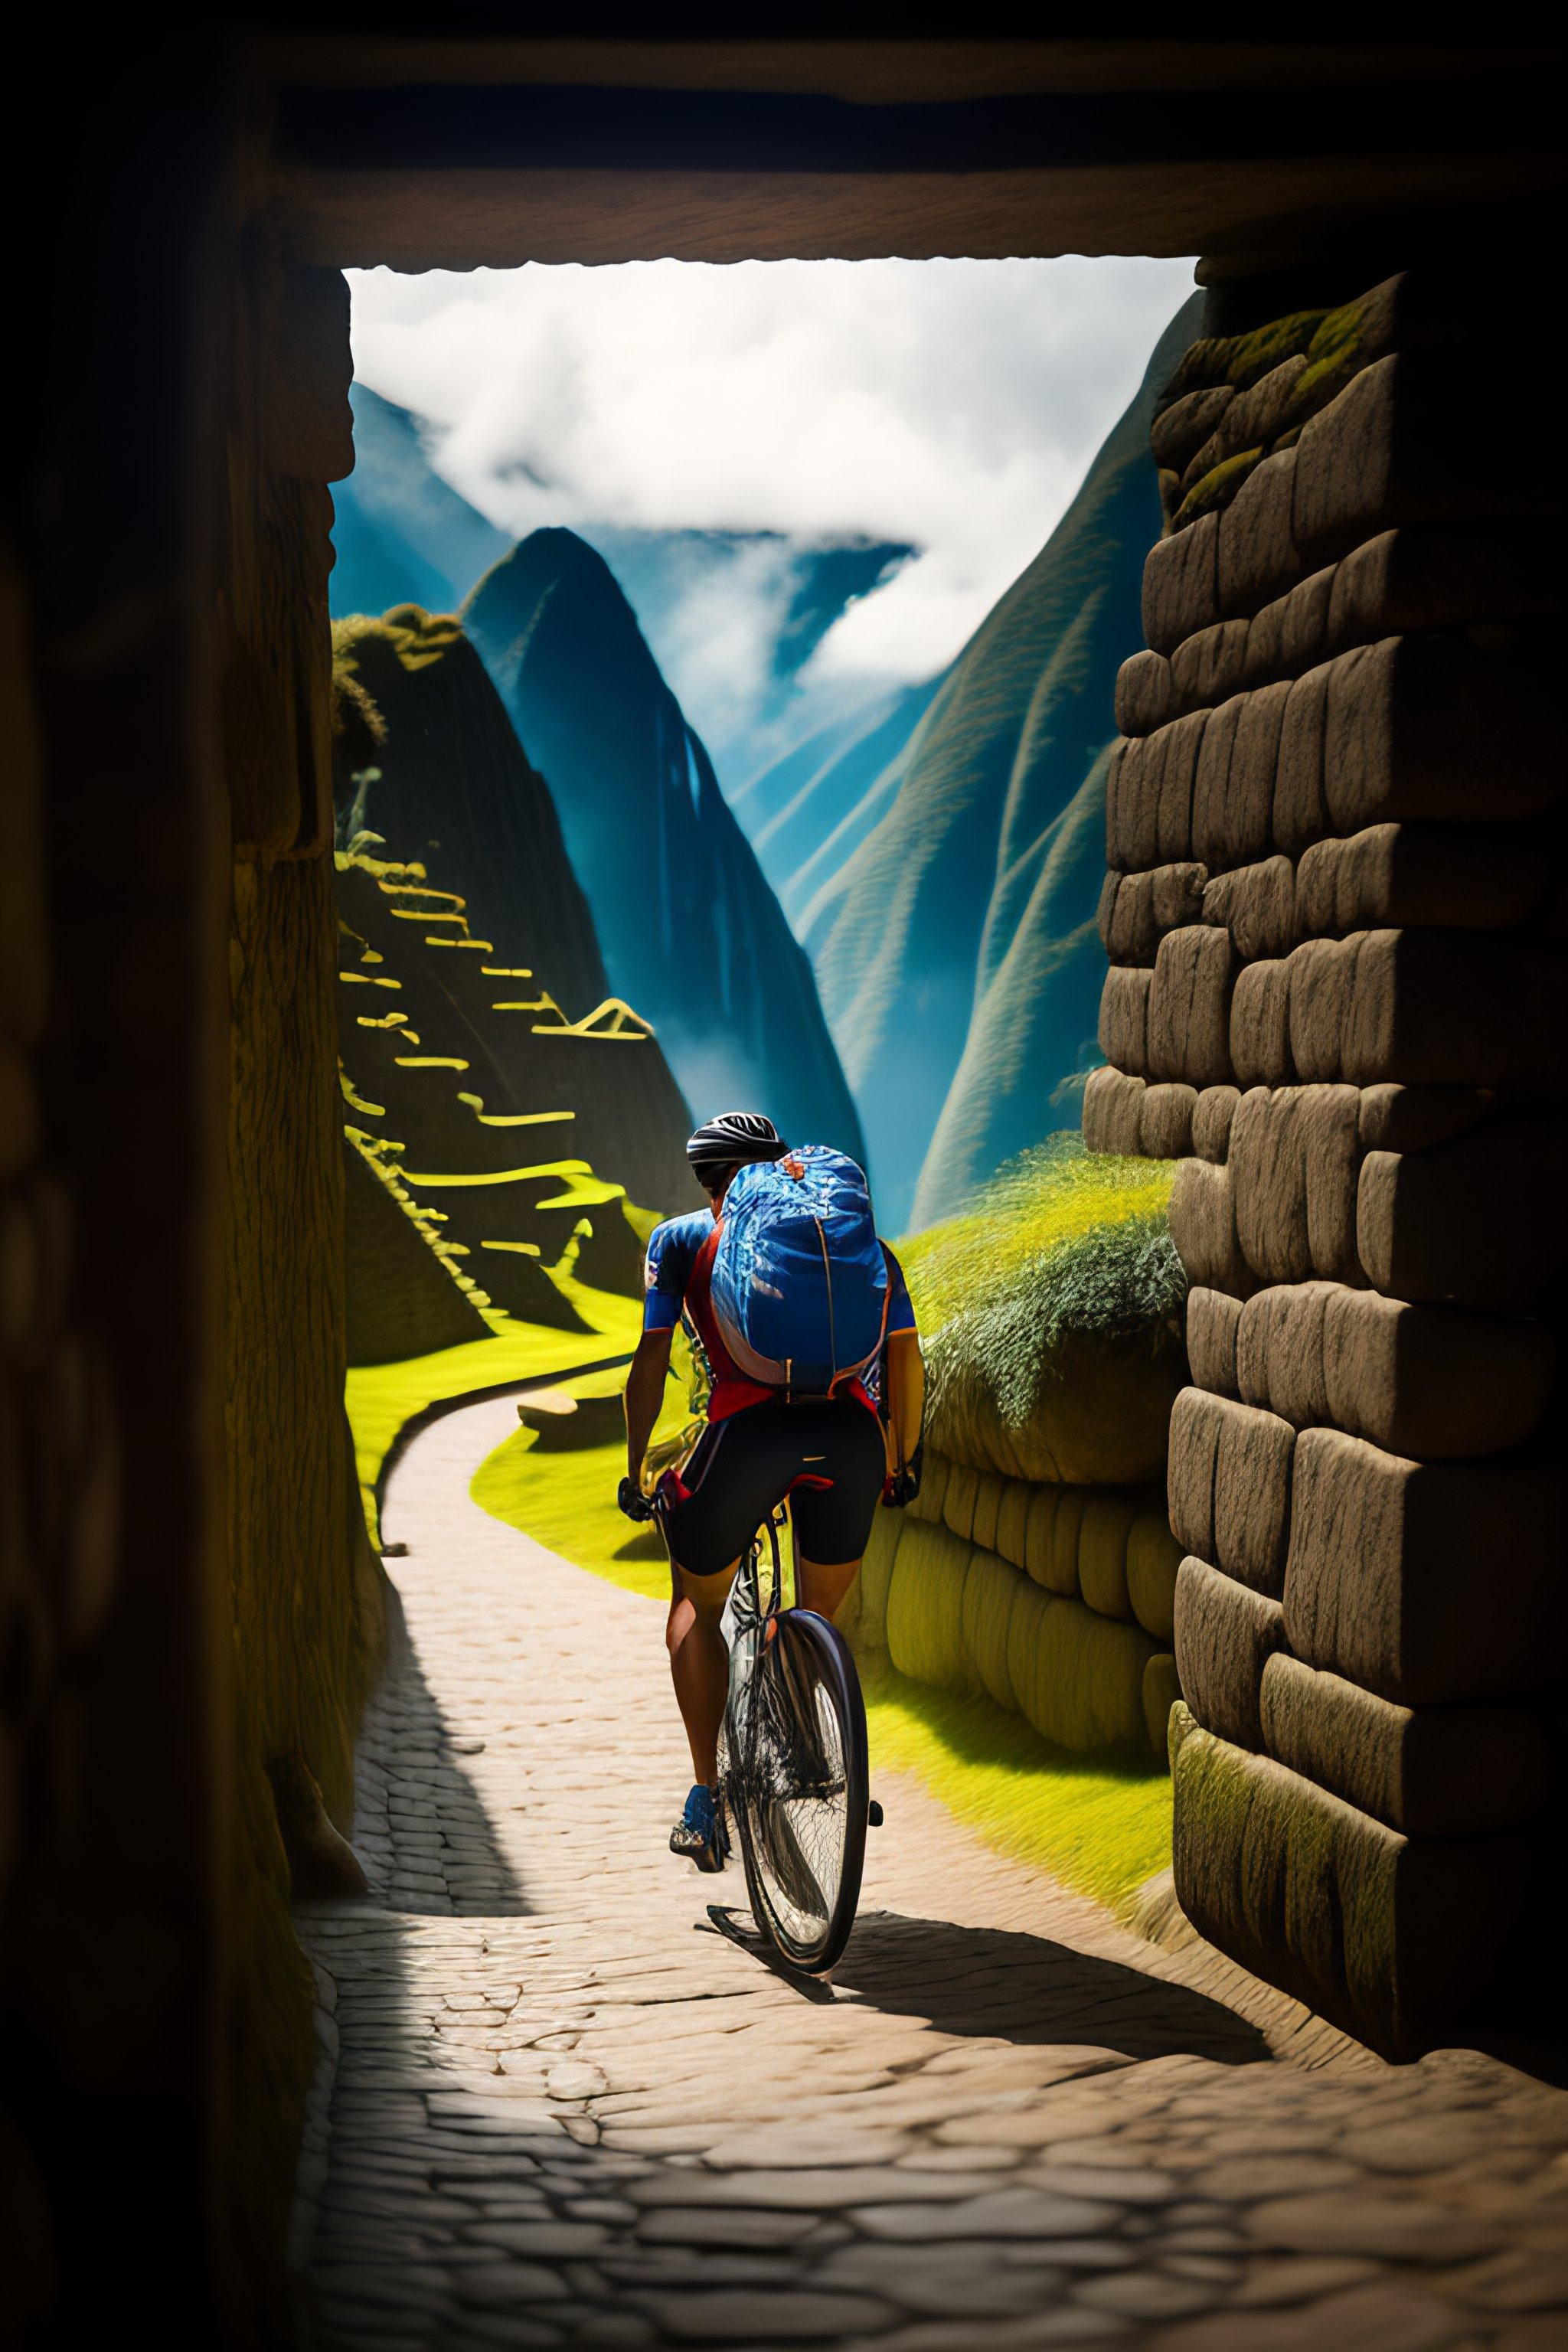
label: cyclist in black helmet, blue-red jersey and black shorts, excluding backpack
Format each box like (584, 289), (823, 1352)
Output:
(621, 1110), (924, 1870)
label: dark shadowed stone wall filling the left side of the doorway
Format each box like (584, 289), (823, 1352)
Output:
(0, 165), (383, 2352)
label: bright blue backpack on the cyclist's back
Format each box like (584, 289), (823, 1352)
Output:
(707, 1143), (889, 1397)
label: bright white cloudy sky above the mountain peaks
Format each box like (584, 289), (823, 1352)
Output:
(350, 256), (1192, 766)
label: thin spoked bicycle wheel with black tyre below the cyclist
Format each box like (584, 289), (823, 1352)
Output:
(731, 1609), (870, 1973)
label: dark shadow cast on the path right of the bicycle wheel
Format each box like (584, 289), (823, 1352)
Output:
(835, 1913), (1272, 2065)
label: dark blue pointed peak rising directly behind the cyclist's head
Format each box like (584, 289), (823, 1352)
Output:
(463, 529), (863, 1157)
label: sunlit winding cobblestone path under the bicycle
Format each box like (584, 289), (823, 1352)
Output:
(296, 1400), (1568, 2352)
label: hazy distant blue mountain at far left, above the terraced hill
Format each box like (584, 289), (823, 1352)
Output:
(329, 384), (508, 621)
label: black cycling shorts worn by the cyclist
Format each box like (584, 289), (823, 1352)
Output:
(663, 1397), (887, 1576)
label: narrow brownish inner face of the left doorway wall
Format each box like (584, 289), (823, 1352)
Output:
(219, 237), (386, 2239)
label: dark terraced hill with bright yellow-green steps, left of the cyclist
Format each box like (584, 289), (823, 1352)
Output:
(334, 607), (701, 1362)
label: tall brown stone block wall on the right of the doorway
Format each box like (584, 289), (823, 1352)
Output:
(1083, 273), (1568, 2056)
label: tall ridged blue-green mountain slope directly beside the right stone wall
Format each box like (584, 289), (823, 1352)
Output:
(797, 296), (1199, 1228)
